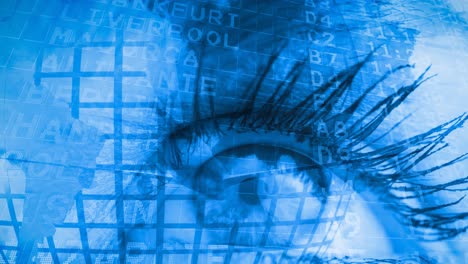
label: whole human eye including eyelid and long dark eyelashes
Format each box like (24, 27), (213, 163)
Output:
(143, 1), (466, 263)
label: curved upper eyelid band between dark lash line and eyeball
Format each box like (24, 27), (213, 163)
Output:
(163, 121), (351, 200)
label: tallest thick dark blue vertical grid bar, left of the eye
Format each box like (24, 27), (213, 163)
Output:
(114, 30), (127, 264)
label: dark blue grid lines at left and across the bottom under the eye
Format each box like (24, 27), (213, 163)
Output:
(1, 27), (354, 264)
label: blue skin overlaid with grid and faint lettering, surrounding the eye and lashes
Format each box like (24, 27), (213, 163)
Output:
(0, 0), (466, 263)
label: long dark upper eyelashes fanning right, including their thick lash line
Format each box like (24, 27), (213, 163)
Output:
(149, 40), (468, 240)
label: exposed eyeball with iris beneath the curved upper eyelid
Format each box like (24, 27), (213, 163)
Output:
(170, 142), (356, 254)
